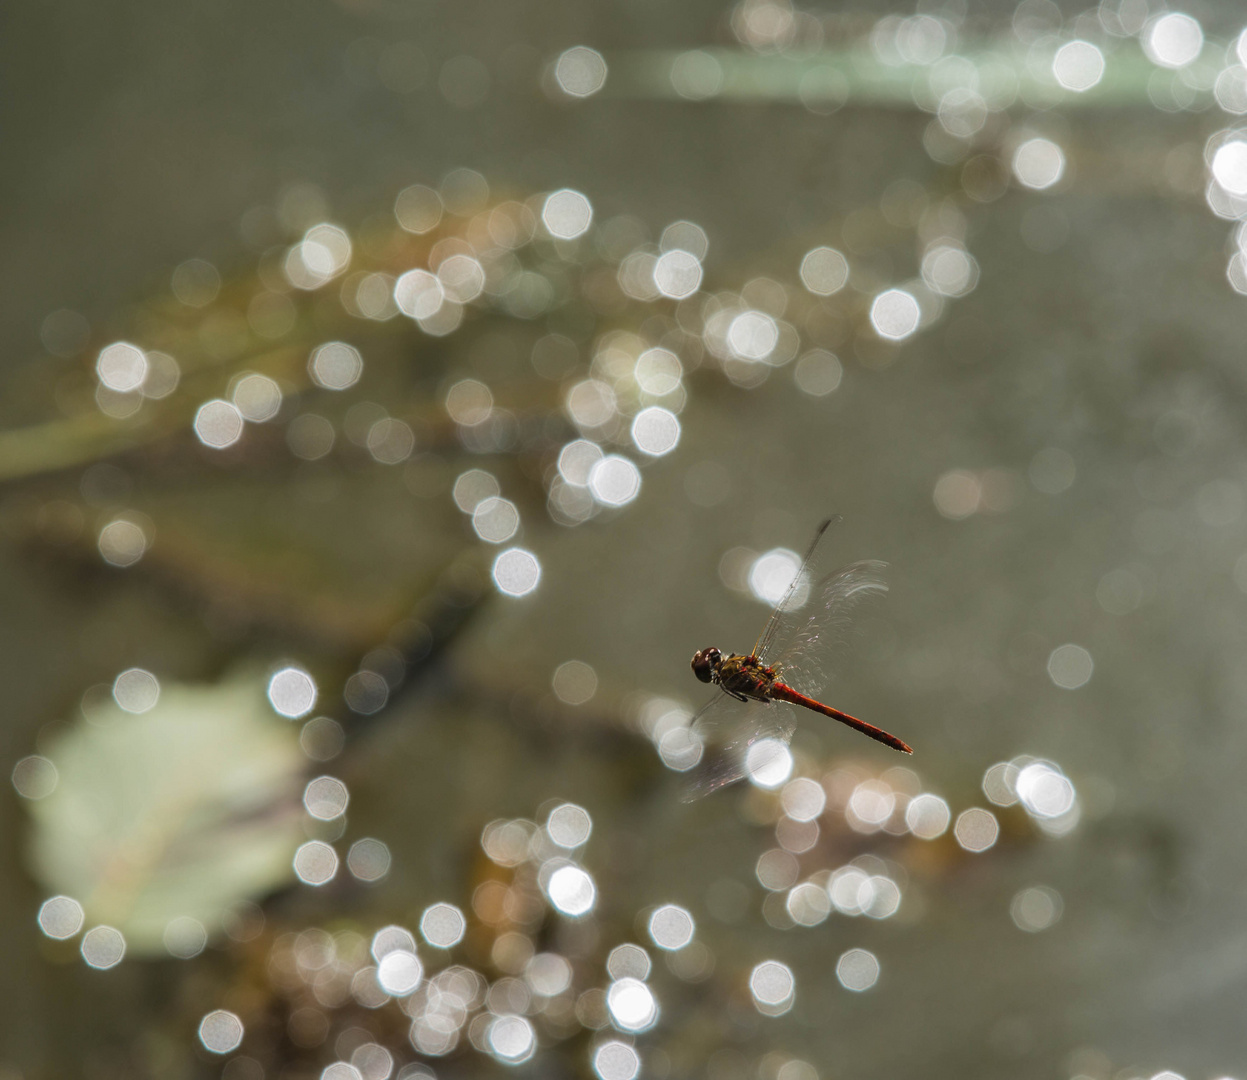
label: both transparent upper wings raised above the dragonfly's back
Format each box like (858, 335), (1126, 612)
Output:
(756, 519), (888, 697)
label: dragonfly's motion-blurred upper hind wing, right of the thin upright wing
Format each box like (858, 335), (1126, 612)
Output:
(762, 560), (888, 697)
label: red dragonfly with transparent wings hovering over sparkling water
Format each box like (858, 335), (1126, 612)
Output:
(692, 518), (913, 798)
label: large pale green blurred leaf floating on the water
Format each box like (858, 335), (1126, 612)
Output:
(30, 675), (304, 955)
